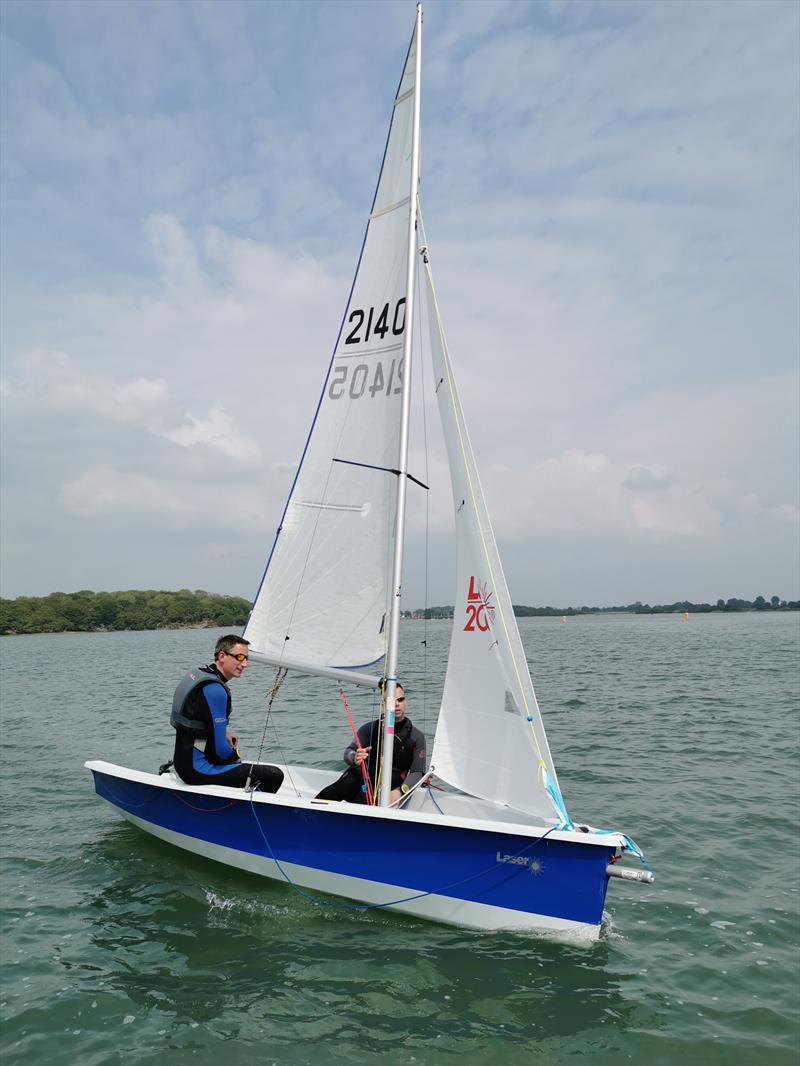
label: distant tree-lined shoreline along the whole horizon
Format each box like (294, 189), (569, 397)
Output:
(0, 588), (800, 636)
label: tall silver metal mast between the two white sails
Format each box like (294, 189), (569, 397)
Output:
(379, 3), (422, 807)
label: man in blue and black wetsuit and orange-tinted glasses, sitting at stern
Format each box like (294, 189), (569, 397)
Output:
(170, 633), (284, 792)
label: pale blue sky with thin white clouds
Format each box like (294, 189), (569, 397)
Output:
(0, 0), (800, 608)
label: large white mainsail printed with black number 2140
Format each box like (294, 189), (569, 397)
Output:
(245, 33), (416, 668)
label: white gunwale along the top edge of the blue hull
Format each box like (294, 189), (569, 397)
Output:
(83, 759), (624, 851)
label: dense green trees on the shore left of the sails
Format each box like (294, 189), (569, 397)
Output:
(0, 588), (250, 634)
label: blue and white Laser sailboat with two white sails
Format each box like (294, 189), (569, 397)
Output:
(85, 6), (653, 940)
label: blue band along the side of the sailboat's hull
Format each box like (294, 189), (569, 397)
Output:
(93, 771), (614, 926)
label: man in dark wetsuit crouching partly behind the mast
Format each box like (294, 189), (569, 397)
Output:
(317, 684), (426, 803)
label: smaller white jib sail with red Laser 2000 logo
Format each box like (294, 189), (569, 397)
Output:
(420, 221), (570, 824)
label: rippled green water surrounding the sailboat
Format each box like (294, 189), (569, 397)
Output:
(0, 614), (800, 1066)
